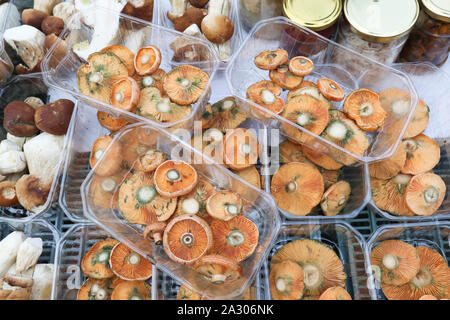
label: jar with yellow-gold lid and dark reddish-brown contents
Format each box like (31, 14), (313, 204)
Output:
(280, 0), (342, 58)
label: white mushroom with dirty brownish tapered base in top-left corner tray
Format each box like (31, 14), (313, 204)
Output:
(4, 24), (45, 70)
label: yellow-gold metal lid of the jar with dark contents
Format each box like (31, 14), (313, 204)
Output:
(283, 0), (342, 31)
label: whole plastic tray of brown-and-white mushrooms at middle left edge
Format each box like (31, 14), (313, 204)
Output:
(0, 74), (78, 222)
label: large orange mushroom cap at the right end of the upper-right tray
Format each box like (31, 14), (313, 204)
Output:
(343, 88), (387, 131)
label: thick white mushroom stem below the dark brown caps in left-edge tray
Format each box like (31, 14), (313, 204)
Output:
(23, 132), (65, 184)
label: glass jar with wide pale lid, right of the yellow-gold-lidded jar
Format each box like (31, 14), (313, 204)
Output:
(332, 0), (419, 69)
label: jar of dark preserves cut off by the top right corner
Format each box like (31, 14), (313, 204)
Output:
(400, 0), (450, 66)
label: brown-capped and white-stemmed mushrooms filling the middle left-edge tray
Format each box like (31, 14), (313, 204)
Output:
(0, 97), (74, 213)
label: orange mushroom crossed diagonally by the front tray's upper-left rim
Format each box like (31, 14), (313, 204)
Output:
(89, 136), (122, 176)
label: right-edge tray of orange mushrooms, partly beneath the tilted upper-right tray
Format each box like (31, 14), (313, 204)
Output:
(369, 63), (450, 222)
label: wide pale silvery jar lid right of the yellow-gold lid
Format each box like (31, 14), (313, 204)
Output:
(344, 0), (420, 42)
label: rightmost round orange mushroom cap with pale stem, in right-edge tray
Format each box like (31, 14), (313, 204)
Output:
(405, 173), (447, 216)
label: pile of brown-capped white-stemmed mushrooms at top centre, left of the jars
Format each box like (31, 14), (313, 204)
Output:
(167, 0), (234, 60)
